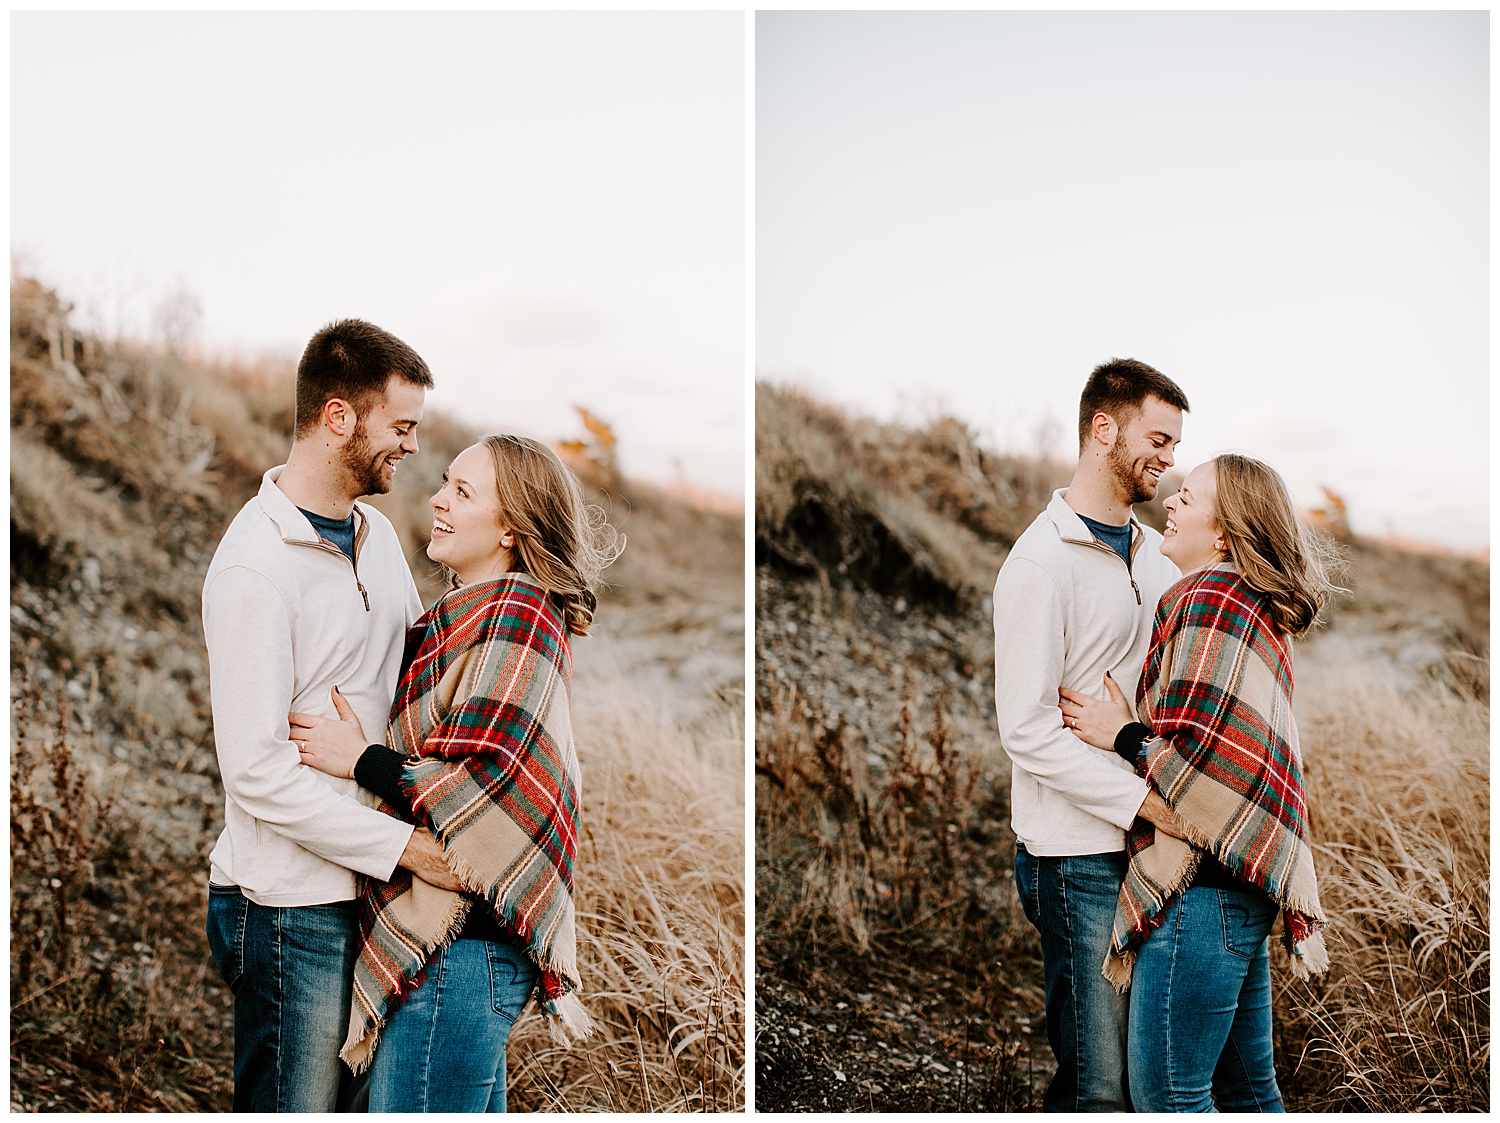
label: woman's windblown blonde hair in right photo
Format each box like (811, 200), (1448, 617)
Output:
(1214, 453), (1344, 636)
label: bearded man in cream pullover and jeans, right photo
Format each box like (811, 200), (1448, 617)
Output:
(995, 358), (1188, 1111)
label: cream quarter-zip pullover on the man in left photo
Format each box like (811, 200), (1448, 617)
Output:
(203, 468), (422, 907)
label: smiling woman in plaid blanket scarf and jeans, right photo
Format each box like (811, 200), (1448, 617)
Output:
(1062, 454), (1335, 1111)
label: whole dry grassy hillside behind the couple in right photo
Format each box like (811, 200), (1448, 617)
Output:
(756, 385), (1490, 1111)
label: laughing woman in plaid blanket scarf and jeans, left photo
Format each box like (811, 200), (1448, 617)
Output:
(291, 436), (624, 1111)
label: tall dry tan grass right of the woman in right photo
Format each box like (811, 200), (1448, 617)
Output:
(1275, 636), (1490, 1111)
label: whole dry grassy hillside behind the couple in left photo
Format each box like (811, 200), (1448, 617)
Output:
(11, 280), (744, 1111)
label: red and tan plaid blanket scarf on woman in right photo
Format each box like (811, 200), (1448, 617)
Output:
(1104, 562), (1328, 991)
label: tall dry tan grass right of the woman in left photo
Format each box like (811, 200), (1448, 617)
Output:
(510, 681), (746, 1111)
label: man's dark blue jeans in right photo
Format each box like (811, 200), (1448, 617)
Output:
(1016, 843), (1130, 1111)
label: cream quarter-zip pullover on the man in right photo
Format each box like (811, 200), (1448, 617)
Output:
(995, 489), (1181, 858)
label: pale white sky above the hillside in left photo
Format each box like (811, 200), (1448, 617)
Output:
(11, 12), (746, 495)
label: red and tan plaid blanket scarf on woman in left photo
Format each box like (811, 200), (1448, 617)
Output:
(341, 573), (593, 1072)
